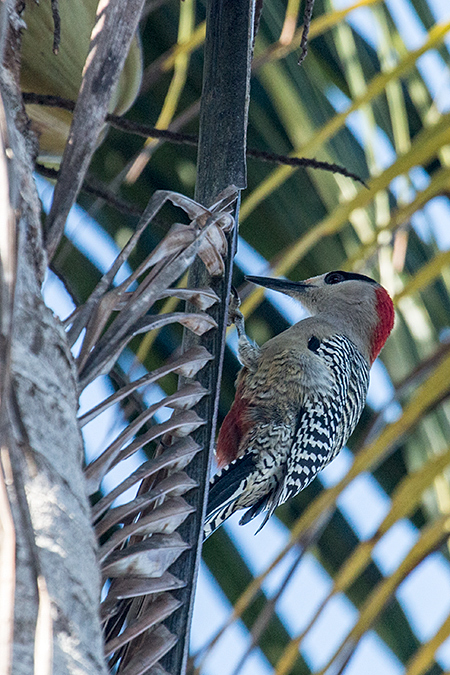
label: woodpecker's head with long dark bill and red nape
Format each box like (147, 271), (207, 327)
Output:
(246, 270), (394, 363)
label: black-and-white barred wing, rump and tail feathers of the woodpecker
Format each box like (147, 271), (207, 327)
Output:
(205, 335), (369, 537)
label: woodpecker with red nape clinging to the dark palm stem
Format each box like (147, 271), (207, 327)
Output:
(204, 270), (394, 538)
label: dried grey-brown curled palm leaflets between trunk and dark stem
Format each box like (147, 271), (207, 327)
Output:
(69, 190), (235, 673)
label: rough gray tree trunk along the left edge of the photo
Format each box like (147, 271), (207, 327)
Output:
(0, 2), (106, 675)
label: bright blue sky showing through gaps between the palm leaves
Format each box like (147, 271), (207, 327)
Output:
(37, 0), (450, 675)
